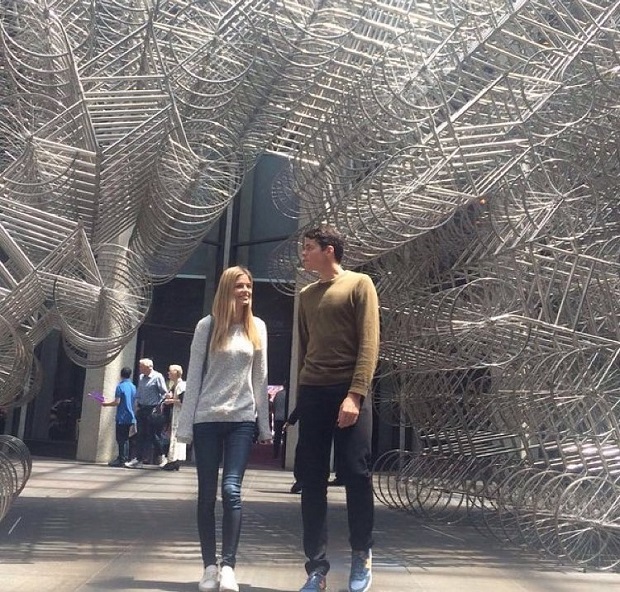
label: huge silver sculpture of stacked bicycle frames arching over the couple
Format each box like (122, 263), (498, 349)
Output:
(0, 0), (620, 569)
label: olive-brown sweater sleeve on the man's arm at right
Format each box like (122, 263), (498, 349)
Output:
(349, 275), (379, 396)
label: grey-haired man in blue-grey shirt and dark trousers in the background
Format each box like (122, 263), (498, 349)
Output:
(125, 358), (168, 469)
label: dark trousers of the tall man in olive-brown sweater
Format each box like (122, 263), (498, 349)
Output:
(295, 384), (374, 574)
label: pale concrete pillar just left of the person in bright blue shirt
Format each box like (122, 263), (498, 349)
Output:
(76, 335), (137, 462)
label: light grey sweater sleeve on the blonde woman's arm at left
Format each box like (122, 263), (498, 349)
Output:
(177, 315), (211, 444)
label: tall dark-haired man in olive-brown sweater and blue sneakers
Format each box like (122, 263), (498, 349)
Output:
(296, 225), (379, 592)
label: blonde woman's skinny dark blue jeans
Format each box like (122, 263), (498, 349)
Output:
(194, 421), (254, 568)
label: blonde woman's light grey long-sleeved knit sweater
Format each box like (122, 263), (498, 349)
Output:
(177, 315), (271, 443)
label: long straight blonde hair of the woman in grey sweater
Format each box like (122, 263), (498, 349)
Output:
(210, 265), (261, 350)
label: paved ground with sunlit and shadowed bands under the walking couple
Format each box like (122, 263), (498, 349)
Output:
(0, 459), (620, 592)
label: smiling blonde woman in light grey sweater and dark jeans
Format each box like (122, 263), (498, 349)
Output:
(177, 266), (271, 592)
